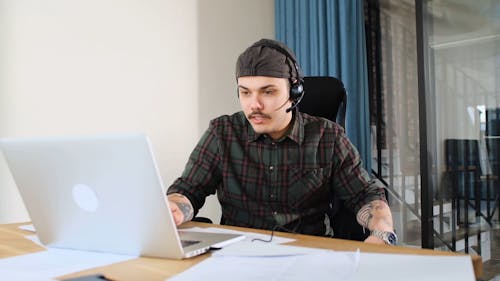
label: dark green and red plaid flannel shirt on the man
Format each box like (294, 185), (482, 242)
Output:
(168, 111), (385, 235)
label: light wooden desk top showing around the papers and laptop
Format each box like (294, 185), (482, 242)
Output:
(0, 222), (483, 281)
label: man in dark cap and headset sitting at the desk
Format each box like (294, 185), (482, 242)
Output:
(168, 39), (396, 244)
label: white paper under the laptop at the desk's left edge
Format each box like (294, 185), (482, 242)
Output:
(0, 248), (136, 280)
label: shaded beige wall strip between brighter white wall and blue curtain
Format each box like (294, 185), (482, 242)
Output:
(198, 0), (274, 222)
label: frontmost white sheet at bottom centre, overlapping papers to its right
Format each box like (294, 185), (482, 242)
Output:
(169, 250), (359, 281)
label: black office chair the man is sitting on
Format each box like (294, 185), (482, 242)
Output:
(299, 76), (369, 241)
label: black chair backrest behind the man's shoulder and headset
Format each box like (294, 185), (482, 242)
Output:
(298, 76), (347, 127)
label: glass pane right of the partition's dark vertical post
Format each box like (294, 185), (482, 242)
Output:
(423, 0), (500, 272)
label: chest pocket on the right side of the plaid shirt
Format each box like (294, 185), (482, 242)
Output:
(287, 165), (331, 208)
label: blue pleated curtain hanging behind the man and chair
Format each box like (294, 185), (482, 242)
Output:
(275, 0), (371, 171)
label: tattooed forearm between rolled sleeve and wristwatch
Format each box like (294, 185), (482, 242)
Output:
(356, 200), (394, 232)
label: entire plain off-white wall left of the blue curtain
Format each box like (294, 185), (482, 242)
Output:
(0, 0), (274, 223)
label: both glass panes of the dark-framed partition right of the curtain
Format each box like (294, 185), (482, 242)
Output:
(367, 0), (500, 276)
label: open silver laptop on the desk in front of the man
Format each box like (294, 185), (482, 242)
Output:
(0, 134), (244, 259)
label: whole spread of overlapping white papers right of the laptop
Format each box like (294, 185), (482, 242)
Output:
(168, 242), (475, 281)
